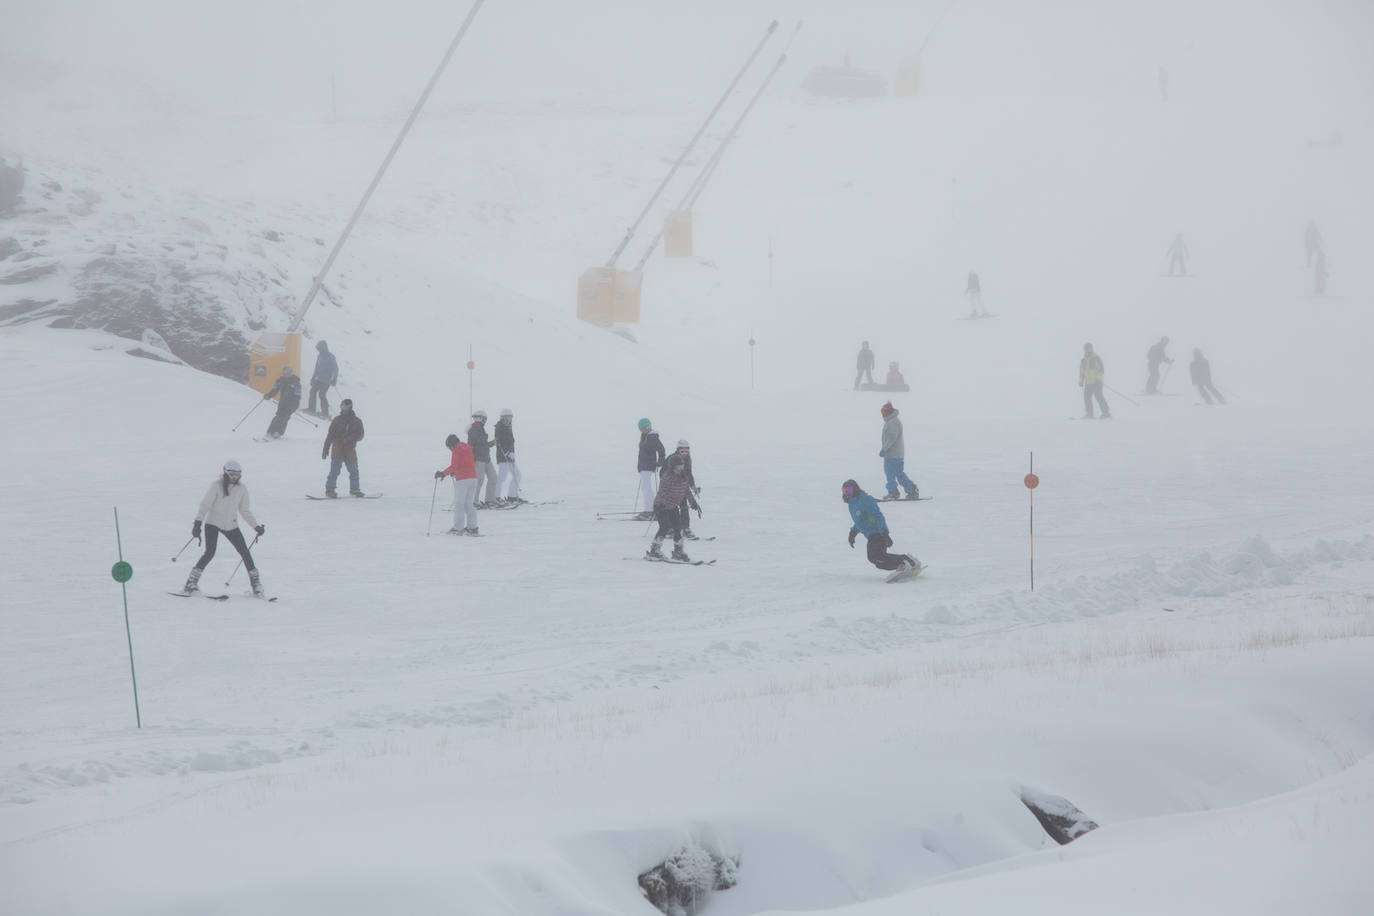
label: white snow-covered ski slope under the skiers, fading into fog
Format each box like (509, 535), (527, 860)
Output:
(0, 3), (1374, 916)
